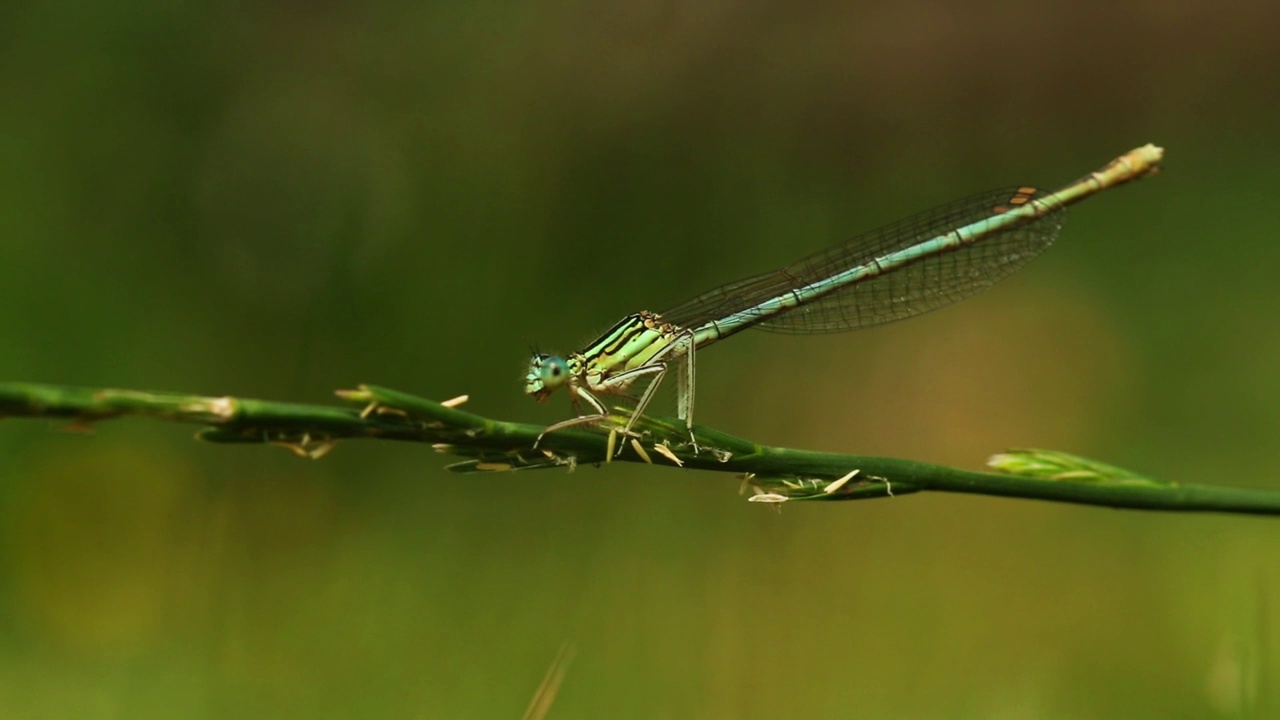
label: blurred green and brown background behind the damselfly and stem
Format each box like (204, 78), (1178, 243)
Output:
(0, 0), (1280, 719)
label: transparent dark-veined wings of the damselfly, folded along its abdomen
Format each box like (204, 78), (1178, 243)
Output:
(662, 187), (1065, 333)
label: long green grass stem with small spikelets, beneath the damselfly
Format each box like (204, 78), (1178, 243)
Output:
(0, 383), (1280, 515)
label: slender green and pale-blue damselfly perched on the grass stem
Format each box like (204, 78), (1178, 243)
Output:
(525, 145), (1164, 451)
